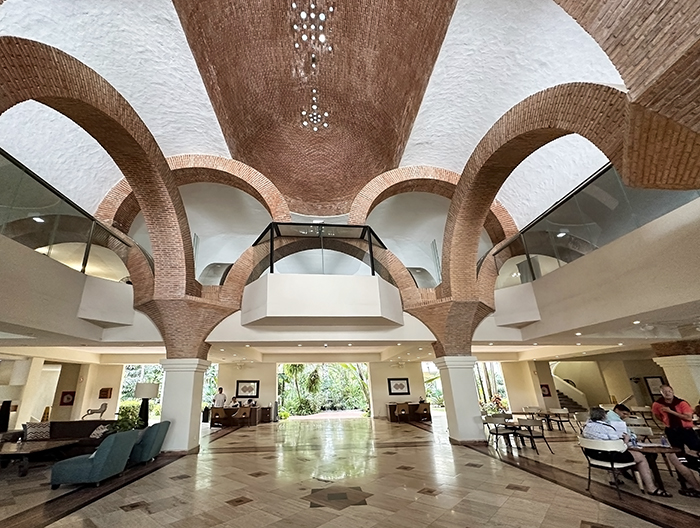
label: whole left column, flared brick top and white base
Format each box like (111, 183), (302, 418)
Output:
(136, 297), (235, 453)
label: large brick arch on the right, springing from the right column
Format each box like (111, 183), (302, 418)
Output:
(441, 83), (627, 300)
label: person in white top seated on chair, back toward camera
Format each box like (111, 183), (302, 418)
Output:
(583, 407), (671, 497)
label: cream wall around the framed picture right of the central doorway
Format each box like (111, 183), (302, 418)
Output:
(369, 362), (425, 418)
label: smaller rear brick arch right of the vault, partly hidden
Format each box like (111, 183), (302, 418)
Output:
(349, 165), (518, 243)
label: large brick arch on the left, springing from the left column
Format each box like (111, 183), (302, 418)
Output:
(0, 37), (199, 297)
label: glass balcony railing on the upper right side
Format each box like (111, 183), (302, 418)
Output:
(493, 165), (700, 289)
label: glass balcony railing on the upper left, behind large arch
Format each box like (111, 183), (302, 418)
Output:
(0, 149), (153, 282)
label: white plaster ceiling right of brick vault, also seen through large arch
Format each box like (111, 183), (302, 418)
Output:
(401, 0), (623, 227)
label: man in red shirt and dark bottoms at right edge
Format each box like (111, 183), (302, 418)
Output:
(651, 385), (700, 497)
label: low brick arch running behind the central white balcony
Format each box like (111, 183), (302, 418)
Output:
(219, 238), (430, 309)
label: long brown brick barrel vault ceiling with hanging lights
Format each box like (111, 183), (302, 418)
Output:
(174, 0), (456, 215)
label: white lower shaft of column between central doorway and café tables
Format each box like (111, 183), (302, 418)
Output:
(434, 356), (486, 444)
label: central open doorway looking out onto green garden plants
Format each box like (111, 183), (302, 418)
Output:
(277, 363), (370, 419)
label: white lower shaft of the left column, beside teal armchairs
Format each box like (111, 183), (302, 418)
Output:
(160, 358), (211, 452)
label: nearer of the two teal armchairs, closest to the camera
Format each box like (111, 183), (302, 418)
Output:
(51, 431), (139, 489)
